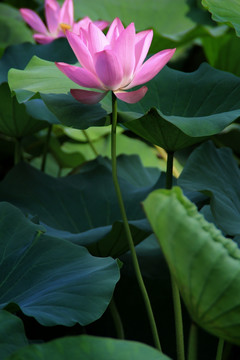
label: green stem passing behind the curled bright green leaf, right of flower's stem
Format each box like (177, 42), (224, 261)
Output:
(166, 151), (185, 360)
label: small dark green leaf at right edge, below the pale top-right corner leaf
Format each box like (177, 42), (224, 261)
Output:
(202, 30), (240, 76)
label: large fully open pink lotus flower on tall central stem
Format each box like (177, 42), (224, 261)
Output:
(56, 18), (175, 104)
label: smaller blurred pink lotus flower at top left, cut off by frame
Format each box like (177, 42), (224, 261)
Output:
(20, 0), (109, 44)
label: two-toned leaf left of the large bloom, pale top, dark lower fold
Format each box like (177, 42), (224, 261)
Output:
(8, 56), (109, 129)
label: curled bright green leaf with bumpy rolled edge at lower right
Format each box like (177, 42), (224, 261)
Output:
(144, 188), (240, 344)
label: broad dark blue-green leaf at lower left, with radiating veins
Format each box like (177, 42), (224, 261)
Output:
(0, 202), (119, 326)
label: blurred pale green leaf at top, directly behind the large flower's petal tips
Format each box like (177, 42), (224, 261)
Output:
(75, 0), (217, 53)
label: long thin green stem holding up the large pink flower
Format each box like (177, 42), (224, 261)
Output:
(111, 92), (162, 351)
